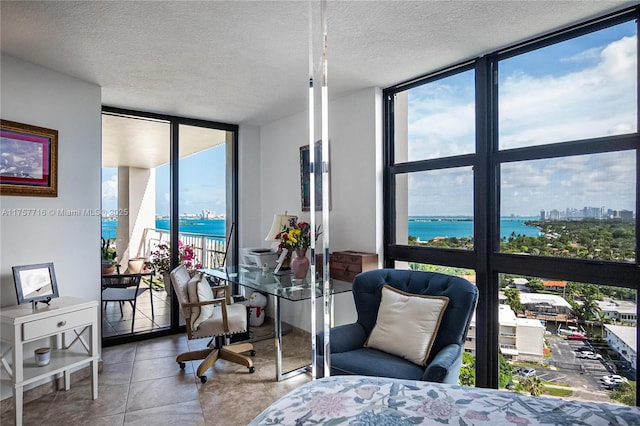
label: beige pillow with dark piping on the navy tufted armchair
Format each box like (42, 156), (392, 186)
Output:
(364, 285), (449, 365)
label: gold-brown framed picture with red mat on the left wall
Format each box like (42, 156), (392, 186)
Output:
(0, 120), (58, 197)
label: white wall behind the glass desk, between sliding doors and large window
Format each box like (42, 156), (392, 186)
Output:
(252, 88), (382, 330)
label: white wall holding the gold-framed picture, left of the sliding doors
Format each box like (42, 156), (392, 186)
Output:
(0, 55), (101, 398)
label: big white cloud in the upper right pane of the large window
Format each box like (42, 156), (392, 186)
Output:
(499, 37), (637, 149)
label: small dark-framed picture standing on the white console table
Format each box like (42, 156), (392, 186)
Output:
(11, 263), (59, 306)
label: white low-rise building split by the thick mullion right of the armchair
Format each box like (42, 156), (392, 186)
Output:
(464, 305), (544, 362)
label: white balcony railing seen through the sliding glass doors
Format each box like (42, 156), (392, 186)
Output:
(138, 228), (226, 268)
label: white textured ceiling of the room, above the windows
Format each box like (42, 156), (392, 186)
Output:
(0, 0), (637, 125)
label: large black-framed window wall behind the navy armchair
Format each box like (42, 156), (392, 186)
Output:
(384, 9), (640, 404)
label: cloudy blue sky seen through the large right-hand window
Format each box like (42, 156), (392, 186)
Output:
(408, 22), (637, 216)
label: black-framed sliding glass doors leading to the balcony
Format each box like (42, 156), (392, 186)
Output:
(102, 107), (237, 344)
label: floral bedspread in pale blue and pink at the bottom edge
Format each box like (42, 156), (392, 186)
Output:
(250, 376), (640, 426)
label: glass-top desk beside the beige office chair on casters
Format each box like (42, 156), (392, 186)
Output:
(201, 265), (352, 381)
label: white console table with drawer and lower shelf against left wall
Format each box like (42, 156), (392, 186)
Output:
(0, 297), (100, 426)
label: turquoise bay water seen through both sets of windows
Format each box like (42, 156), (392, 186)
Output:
(102, 216), (540, 241)
